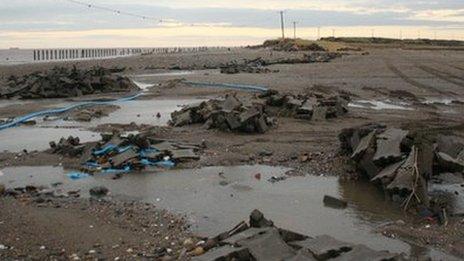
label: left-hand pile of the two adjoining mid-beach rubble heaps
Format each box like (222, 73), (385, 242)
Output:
(170, 95), (275, 133)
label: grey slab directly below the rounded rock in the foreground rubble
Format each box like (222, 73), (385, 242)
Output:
(237, 228), (296, 261)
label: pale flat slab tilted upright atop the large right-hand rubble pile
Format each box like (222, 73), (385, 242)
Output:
(373, 128), (409, 165)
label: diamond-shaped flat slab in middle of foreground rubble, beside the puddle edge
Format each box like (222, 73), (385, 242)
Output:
(289, 235), (353, 260)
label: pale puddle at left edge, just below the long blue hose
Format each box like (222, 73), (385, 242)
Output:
(0, 126), (100, 152)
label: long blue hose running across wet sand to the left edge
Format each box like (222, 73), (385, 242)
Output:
(0, 93), (142, 130)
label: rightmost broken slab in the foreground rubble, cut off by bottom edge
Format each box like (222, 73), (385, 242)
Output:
(332, 245), (402, 261)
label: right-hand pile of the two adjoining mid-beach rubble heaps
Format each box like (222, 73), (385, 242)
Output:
(260, 90), (350, 121)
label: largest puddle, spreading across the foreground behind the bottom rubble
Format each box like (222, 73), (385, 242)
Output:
(0, 165), (454, 256)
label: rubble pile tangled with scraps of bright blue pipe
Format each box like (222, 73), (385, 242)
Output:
(50, 132), (203, 173)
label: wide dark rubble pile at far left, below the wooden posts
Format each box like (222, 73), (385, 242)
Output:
(0, 67), (138, 99)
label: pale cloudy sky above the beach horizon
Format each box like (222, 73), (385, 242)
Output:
(0, 0), (464, 49)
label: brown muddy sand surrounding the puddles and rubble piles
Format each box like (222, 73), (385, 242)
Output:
(0, 46), (464, 258)
